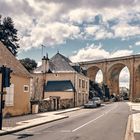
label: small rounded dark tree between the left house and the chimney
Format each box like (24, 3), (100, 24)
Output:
(20, 58), (37, 72)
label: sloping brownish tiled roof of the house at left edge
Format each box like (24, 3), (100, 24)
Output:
(0, 42), (31, 77)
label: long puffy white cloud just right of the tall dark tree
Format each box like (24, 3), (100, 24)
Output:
(21, 22), (80, 49)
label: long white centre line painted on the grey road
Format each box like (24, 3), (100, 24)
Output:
(72, 105), (118, 132)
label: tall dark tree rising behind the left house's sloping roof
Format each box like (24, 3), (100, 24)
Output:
(0, 16), (19, 56)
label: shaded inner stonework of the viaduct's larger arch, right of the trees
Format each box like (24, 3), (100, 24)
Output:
(107, 63), (130, 95)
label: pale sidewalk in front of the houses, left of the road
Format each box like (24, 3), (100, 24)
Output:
(0, 107), (82, 136)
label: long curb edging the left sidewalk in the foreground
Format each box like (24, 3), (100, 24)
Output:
(0, 116), (69, 136)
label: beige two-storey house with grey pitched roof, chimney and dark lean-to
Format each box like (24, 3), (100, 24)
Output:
(32, 52), (89, 110)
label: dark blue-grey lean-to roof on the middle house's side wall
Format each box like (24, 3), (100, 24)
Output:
(45, 80), (74, 92)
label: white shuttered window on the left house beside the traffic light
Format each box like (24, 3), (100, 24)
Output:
(5, 84), (14, 106)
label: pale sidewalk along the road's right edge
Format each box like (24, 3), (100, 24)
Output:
(128, 102), (140, 140)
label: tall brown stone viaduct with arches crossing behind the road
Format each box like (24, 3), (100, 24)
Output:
(79, 55), (140, 100)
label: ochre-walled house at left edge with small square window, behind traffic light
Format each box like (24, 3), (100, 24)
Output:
(0, 42), (31, 116)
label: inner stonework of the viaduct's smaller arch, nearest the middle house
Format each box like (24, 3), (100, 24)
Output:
(87, 66), (104, 81)
